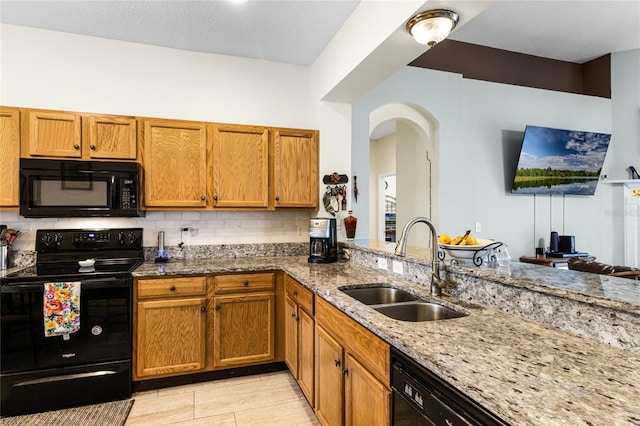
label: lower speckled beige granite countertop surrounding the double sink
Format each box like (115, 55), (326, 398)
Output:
(134, 256), (640, 425)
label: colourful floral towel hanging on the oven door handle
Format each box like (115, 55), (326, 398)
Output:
(43, 281), (80, 339)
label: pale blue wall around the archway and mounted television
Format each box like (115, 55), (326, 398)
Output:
(352, 58), (640, 263)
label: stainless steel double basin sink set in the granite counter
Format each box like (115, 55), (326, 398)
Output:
(340, 285), (467, 322)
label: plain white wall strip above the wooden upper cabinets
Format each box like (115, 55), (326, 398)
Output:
(0, 24), (316, 128)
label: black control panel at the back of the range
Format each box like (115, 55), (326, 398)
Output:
(36, 228), (142, 253)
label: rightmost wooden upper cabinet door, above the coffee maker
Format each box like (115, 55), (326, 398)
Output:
(273, 129), (319, 208)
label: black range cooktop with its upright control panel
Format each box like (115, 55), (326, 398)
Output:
(2, 228), (144, 285)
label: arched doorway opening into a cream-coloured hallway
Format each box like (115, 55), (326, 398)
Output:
(368, 103), (438, 247)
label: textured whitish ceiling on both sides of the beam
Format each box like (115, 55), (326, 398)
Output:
(0, 0), (640, 65)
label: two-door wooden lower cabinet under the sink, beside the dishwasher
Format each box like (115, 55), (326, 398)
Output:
(315, 298), (391, 426)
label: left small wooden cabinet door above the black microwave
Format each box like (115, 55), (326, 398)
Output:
(22, 110), (82, 158)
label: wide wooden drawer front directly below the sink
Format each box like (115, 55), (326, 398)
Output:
(316, 298), (391, 386)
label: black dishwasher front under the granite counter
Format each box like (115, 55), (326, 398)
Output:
(391, 348), (508, 426)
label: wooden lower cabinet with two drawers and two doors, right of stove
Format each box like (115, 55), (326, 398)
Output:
(133, 272), (276, 380)
